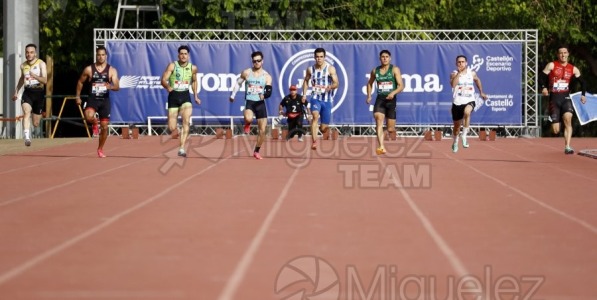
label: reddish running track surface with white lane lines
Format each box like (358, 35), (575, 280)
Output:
(0, 137), (597, 300)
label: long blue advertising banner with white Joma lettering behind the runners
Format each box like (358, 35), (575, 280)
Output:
(106, 41), (523, 125)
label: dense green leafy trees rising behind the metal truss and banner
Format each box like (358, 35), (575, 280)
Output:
(1, 0), (597, 136)
